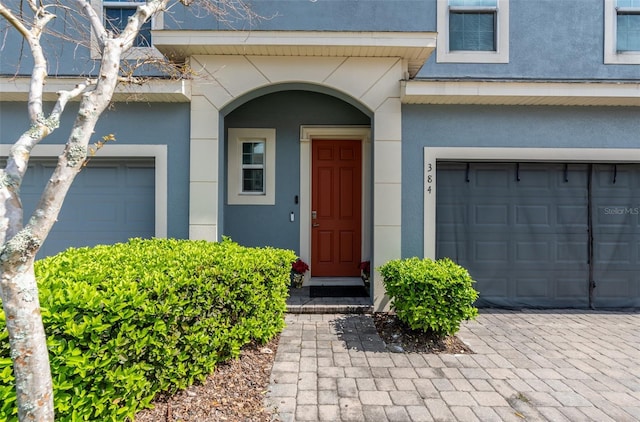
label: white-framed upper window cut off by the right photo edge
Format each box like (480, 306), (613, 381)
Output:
(604, 0), (640, 64)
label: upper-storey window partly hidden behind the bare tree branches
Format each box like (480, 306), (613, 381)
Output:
(91, 0), (163, 59)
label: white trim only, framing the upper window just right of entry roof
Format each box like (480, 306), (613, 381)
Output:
(436, 0), (509, 63)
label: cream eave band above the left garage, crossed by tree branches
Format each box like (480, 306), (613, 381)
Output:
(0, 77), (191, 102)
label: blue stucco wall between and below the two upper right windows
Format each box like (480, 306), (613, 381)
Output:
(418, 0), (640, 80)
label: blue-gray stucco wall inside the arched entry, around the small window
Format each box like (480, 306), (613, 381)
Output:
(221, 91), (371, 253)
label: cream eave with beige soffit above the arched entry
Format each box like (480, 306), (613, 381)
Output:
(153, 30), (436, 78)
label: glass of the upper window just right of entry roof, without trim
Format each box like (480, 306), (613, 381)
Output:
(449, 11), (496, 51)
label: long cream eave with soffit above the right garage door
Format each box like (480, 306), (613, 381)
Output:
(402, 80), (640, 106)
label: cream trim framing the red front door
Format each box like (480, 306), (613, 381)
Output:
(300, 126), (372, 282)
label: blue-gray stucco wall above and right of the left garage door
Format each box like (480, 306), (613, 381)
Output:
(0, 102), (190, 238)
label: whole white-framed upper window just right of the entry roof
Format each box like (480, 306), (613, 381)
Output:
(436, 0), (509, 63)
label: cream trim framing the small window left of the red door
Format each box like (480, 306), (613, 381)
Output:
(227, 128), (276, 205)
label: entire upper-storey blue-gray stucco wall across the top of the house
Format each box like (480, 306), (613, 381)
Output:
(0, 0), (640, 80)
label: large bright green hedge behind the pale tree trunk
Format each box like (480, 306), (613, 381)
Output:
(0, 239), (296, 421)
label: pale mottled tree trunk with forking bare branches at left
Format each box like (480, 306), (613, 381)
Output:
(0, 0), (168, 422)
